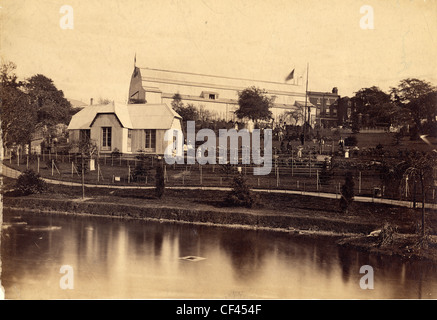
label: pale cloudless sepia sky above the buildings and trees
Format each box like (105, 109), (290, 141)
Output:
(0, 0), (437, 103)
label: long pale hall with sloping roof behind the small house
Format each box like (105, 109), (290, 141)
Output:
(129, 67), (315, 125)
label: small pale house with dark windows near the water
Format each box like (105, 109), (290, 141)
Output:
(68, 103), (182, 154)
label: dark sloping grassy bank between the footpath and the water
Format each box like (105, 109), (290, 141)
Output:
(4, 182), (437, 261)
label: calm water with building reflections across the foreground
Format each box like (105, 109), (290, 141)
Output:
(1, 210), (437, 299)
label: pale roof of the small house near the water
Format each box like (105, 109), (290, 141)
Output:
(68, 102), (182, 130)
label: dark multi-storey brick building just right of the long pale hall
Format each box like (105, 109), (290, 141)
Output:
(308, 88), (340, 128)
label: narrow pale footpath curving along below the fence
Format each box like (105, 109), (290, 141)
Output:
(2, 165), (437, 209)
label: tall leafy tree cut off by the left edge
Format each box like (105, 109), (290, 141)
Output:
(0, 62), (37, 147)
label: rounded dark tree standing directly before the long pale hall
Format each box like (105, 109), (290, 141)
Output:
(235, 87), (273, 122)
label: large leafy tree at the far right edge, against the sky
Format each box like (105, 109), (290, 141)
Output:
(391, 78), (436, 133)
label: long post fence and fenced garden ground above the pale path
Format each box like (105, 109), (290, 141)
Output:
(4, 148), (436, 203)
